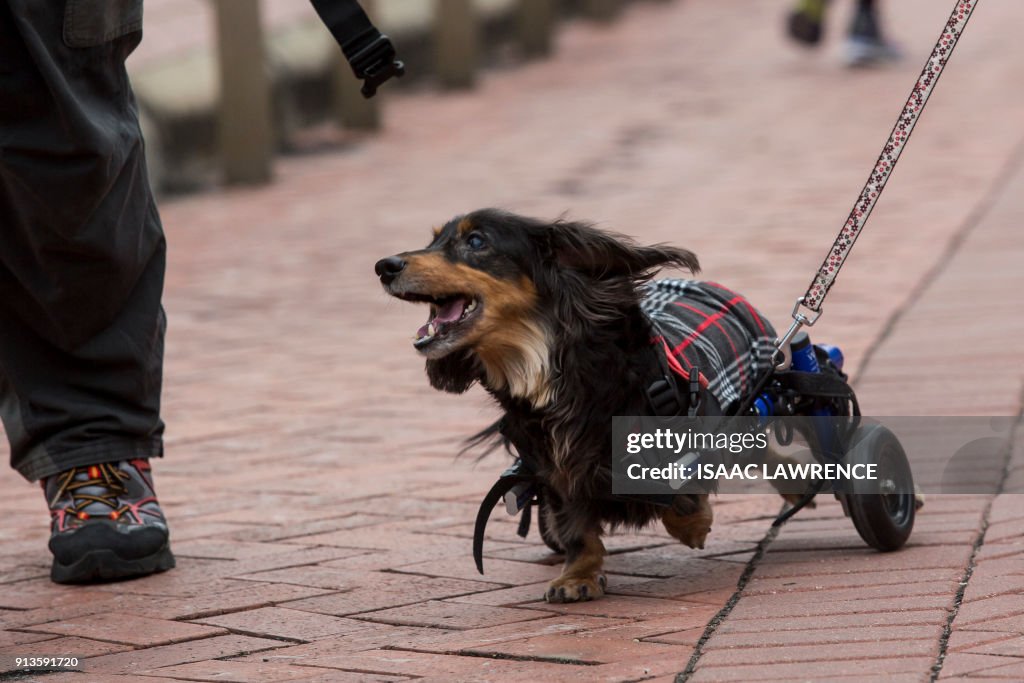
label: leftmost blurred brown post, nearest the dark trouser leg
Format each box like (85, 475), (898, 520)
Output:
(213, 0), (274, 183)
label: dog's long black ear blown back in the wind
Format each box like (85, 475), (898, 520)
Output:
(548, 221), (700, 280)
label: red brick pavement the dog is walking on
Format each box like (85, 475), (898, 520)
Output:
(0, 0), (1024, 681)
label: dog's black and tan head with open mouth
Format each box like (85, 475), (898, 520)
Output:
(376, 209), (698, 408)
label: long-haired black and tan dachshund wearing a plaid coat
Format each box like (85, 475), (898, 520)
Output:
(376, 209), (774, 602)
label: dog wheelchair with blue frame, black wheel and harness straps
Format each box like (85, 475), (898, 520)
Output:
(473, 333), (920, 573)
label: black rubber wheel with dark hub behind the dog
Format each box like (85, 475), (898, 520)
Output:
(846, 425), (916, 552)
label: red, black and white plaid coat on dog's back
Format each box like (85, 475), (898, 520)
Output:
(641, 280), (776, 411)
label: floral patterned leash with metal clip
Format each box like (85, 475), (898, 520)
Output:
(775, 0), (978, 371)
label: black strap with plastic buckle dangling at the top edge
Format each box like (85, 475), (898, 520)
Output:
(309, 0), (406, 99)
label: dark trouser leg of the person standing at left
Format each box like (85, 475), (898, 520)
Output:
(0, 0), (165, 479)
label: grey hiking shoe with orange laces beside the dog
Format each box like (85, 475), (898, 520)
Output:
(41, 460), (174, 584)
